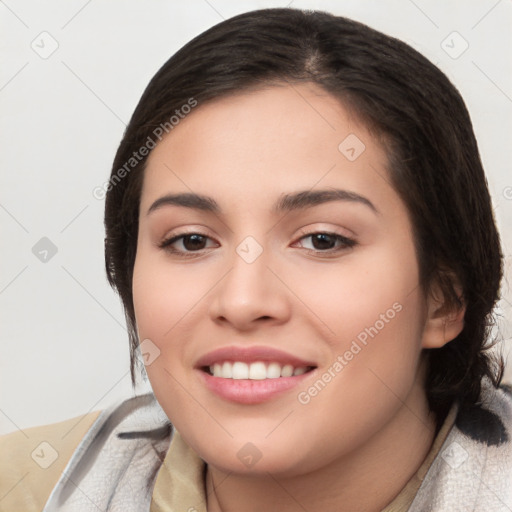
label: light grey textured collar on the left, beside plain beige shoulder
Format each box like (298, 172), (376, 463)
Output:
(33, 393), (172, 512)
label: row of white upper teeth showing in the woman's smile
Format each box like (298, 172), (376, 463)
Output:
(210, 361), (308, 380)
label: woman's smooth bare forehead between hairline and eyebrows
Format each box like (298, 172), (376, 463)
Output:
(142, 83), (396, 218)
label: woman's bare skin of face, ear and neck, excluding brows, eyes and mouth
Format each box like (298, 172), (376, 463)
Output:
(133, 84), (463, 512)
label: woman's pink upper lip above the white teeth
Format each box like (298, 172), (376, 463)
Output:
(196, 346), (316, 368)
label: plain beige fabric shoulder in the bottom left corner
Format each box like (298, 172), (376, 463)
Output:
(0, 411), (100, 512)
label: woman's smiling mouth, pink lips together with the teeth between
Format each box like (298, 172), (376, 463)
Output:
(195, 347), (317, 404)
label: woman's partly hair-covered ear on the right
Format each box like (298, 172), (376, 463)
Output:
(421, 274), (466, 348)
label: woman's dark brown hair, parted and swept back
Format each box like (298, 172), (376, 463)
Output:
(105, 9), (503, 418)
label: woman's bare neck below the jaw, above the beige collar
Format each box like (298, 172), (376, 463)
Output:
(206, 376), (436, 512)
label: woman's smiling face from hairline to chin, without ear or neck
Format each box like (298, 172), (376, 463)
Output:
(133, 84), (436, 474)
